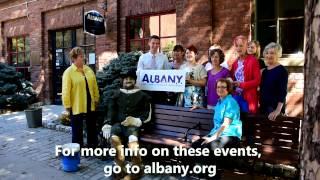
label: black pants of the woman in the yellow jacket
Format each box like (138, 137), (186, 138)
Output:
(70, 112), (98, 147)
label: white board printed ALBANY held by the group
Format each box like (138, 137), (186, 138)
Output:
(137, 70), (186, 92)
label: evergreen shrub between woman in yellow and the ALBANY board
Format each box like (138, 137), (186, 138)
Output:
(97, 52), (142, 110)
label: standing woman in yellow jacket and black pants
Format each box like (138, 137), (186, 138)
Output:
(62, 47), (99, 147)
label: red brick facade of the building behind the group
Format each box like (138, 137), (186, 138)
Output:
(0, 0), (303, 115)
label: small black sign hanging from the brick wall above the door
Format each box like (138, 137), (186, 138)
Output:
(83, 10), (105, 35)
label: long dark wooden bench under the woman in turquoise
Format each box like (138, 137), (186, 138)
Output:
(140, 105), (301, 167)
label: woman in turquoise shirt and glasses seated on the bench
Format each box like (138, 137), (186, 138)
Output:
(192, 79), (242, 151)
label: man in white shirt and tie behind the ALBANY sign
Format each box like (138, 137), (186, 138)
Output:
(137, 35), (170, 71)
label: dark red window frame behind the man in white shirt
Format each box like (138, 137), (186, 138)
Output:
(126, 10), (177, 52)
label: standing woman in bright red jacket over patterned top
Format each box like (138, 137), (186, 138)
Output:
(231, 36), (261, 113)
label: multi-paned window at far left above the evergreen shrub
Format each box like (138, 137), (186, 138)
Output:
(8, 36), (30, 80)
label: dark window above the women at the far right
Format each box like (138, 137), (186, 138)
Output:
(256, 0), (304, 55)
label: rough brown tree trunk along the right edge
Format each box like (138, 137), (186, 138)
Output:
(300, 0), (320, 180)
